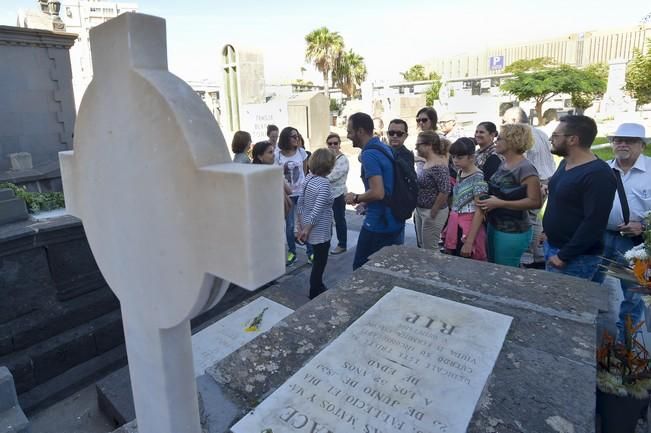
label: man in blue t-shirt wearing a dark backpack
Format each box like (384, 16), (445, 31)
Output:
(346, 113), (418, 270)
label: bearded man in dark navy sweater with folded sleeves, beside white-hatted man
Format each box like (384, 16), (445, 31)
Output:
(543, 116), (617, 280)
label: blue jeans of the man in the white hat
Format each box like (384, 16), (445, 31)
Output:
(592, 230), (644, 338)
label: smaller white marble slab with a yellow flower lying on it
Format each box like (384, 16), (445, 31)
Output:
(192, 296), (294, 377)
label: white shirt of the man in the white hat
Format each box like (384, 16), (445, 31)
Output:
(607, 154), (651, 230)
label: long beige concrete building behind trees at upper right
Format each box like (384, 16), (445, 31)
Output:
(424, 23), (651, 80)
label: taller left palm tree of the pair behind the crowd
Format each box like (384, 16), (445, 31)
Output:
(305, 27), (344, 98)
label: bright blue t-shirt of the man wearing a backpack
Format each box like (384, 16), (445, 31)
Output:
(362, 137), (405, 233)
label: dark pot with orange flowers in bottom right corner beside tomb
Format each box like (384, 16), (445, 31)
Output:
(597, 317), (651, 433)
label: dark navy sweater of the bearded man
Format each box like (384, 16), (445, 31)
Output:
(543, 159), (617, 261)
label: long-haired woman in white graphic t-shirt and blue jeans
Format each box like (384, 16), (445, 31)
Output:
(275, 126), (312, 266)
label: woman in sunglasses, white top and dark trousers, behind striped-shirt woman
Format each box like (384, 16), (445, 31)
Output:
(326, 132), (349, 255)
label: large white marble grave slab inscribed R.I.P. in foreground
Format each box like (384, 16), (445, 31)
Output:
(231, 287), (511, 433)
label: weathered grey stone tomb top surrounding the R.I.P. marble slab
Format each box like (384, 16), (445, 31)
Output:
(114, 247), (607, 433)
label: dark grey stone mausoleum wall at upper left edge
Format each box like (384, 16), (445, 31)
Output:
(0, 26), (77, 190)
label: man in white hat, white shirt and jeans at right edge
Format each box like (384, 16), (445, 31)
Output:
(595, 123), (651, 341)
